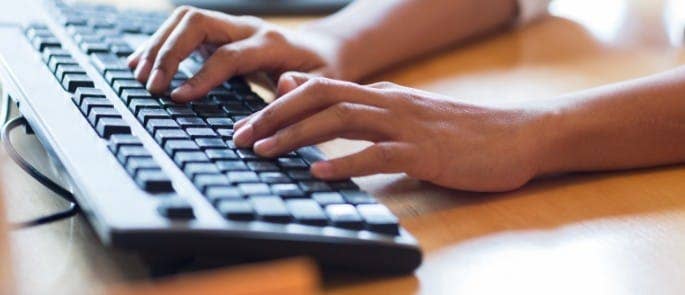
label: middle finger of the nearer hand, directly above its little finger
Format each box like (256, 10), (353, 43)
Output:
(254, 103), (395, 157)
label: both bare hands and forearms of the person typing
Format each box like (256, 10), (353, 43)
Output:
(129, 0), (685, 191)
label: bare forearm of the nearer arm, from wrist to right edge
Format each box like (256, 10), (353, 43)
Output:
(538, 67), (685, 174)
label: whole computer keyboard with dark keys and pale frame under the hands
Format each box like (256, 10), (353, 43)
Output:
(0, 0), (422, 272)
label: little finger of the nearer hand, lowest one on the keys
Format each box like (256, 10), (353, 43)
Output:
(311, 142), (416, 180)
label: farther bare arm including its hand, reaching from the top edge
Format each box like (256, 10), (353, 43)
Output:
(129, 0), (516, 101)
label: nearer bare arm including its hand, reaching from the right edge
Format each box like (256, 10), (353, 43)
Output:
(234, 67), (685, 191)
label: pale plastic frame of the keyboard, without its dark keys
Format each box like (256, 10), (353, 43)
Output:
(0, 0), (422, 272)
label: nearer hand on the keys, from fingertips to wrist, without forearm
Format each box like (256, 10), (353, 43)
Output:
(234, 73), (541, 191)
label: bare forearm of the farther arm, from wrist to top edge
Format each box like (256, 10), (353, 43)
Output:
(304, 0), (517, 81)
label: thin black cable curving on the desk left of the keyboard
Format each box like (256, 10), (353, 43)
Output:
(0, 116), (80, 229)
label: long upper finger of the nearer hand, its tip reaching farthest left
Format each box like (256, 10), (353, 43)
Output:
(234, 78), (389, 147)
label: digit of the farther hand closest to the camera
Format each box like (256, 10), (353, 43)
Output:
(171, 39), (271, 102)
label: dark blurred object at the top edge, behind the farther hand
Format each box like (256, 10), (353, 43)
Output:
(171, 0), (352, 15)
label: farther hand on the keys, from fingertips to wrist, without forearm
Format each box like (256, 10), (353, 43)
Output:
(128, 6), (339, 102)
